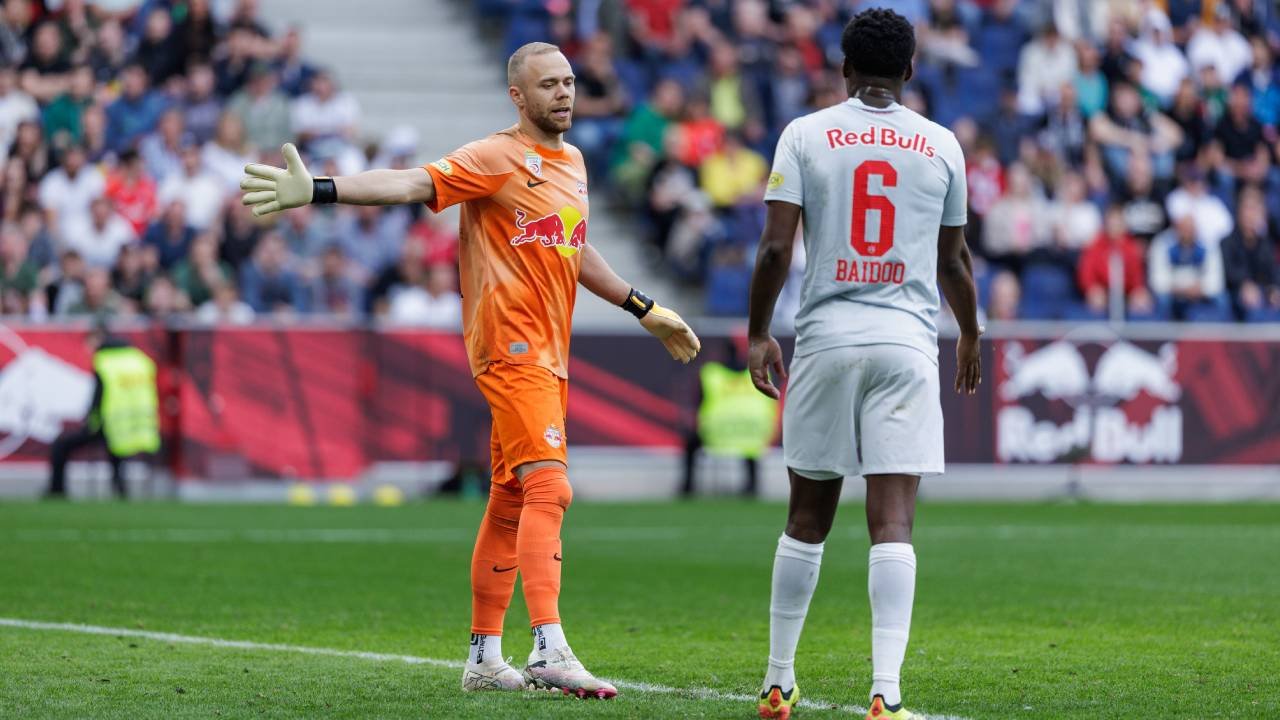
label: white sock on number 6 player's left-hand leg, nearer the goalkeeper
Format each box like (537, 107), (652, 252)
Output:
(764, 534), (822, 692)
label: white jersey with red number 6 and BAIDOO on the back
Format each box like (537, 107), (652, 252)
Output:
(764, 99), (968, 363)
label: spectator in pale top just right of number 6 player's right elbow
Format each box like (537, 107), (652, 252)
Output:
(982, 163), (1050, 272)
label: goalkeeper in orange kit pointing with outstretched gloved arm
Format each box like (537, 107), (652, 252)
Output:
(241, 42), (700, 698)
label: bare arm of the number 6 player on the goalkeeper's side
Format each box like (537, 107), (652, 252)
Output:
(746, 200), (800, 398)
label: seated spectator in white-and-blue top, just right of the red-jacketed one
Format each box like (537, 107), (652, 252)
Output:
(1148, 208), (1226, 320)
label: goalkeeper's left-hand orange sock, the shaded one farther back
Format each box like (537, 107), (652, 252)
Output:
(471, 483), (524, 635)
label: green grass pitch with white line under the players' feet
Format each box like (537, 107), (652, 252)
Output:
(0, 501), (1280, 720)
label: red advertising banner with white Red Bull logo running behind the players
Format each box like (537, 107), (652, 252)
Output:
(0, 325), (1280, 480)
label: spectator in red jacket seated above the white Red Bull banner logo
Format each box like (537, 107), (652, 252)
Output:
(1076, 205), (1155, 316)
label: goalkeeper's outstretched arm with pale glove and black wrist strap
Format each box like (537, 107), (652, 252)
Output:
(241, 142), (435, 217)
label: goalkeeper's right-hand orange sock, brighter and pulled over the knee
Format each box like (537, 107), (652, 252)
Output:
(516, 468), (573, 626)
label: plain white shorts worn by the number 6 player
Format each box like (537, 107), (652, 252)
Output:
(782, 345), (943, 480)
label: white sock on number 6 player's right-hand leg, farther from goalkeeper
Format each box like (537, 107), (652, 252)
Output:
(867, 542), (915, 705)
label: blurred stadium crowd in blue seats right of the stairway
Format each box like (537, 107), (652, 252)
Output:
(491, 0), (1280, 320)
